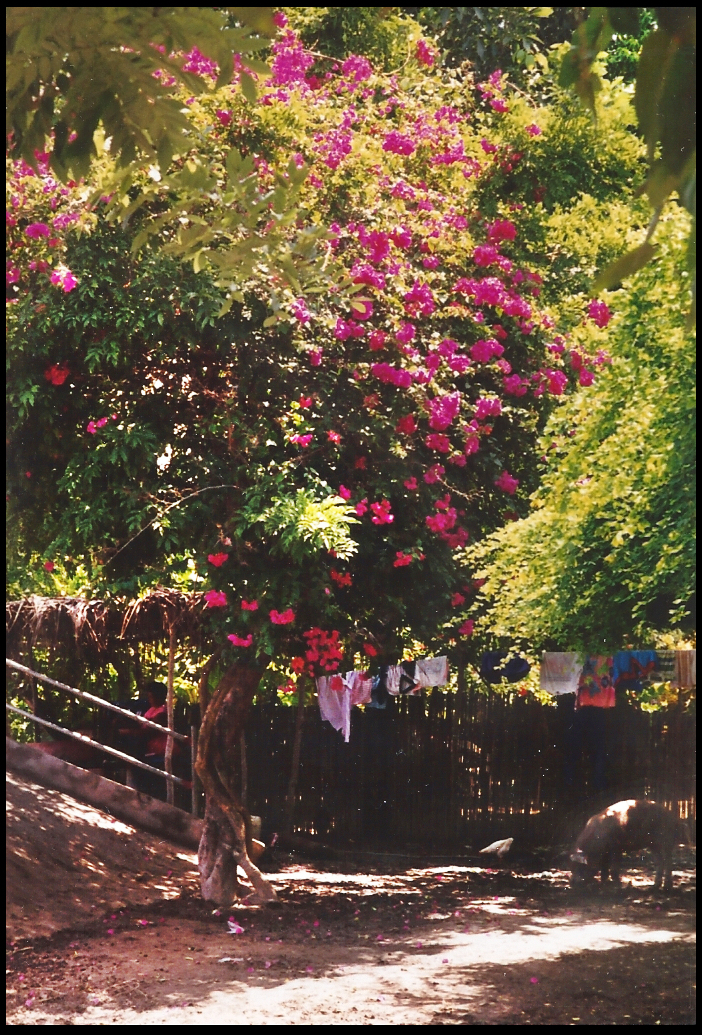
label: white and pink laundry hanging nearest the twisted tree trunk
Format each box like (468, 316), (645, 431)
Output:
(317, 657), (448, 744)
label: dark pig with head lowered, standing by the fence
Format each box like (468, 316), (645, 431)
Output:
(571, 799), (679, 890)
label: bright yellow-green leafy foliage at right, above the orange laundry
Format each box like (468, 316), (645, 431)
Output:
(471, 212), (696, 650)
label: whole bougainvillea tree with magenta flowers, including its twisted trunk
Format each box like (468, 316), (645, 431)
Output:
(7, 19), (650, 900)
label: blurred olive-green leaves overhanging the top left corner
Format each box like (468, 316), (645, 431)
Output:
(6, 7), (274, 180)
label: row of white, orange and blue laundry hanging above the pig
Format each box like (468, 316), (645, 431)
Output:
(539, 650), (697, 708)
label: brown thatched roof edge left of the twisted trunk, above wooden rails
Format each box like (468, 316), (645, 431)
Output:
(5, 587), (209, 661)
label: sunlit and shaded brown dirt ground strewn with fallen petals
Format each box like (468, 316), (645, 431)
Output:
(6, 776), (695, 1025)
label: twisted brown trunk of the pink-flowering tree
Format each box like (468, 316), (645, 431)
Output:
(196, 664), (276, 906)
